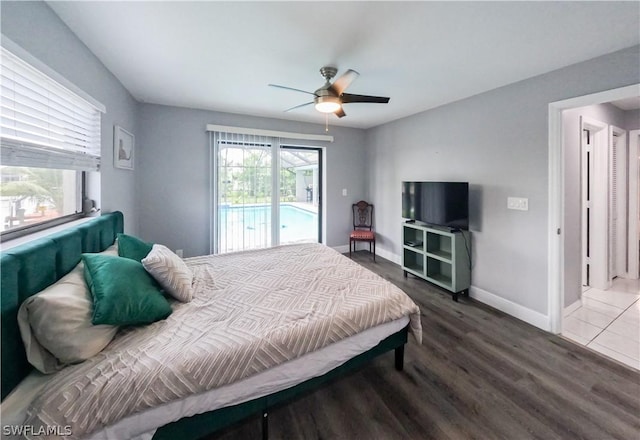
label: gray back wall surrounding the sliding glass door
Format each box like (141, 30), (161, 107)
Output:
(136, 104), (366, 257)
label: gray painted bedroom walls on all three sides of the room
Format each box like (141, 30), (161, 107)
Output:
(1, 2), (640, 324)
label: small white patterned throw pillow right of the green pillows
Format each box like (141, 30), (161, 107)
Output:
(142, 244), (193, 302)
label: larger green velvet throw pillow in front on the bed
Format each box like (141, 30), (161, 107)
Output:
(82, 254), (172, 325)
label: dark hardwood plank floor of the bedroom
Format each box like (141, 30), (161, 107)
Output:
(208, 251), (640, 440)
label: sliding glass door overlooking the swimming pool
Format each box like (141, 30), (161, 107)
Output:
(212, 133), (322, 253)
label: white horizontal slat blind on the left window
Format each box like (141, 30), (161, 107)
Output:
(0, 47), (102, 171)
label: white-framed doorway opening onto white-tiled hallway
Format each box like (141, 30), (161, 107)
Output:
(549, 85), (640, 368)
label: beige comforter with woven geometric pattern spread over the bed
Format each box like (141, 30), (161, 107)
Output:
(25, 244), (422, 438)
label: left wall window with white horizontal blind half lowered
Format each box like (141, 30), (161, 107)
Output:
(0, 41), (104, 240)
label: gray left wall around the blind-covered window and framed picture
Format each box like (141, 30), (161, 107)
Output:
(0, 1), (139, 233)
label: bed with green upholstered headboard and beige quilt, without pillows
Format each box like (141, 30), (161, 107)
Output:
(0, 212), (421, 439)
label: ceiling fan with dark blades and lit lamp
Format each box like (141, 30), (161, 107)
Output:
(269, 66), (389, 118)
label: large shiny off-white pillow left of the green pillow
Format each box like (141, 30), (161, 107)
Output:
(18, 246), (118, 374)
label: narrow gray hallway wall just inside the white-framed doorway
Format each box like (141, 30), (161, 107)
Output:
(562, 104), (640, 307)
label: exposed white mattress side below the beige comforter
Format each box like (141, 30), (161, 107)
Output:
(0, 317), (409, 440)
